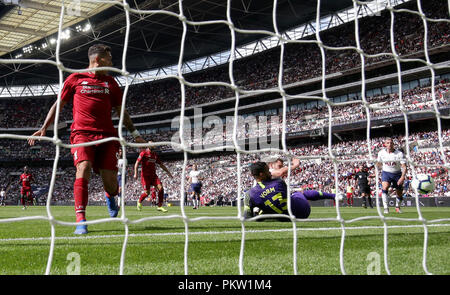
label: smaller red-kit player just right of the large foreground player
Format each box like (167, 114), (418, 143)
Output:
(134, 141), (173, 212)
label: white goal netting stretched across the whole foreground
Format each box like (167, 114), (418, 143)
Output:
(0, 0), (450, 274)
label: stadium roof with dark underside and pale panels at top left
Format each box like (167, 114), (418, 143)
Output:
(0, 0), (353, 86)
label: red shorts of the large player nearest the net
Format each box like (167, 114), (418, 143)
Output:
(70, 131), (120, 173)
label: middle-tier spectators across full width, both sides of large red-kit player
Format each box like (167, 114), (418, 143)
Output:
(0, 80), (450, 159)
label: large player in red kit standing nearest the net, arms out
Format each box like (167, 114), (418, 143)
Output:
(28, 44), (145, 234)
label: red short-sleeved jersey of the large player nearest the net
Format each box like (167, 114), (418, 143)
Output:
(61, 72), (122, 134)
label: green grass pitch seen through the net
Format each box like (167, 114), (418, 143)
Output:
(0, 206), (450, 275)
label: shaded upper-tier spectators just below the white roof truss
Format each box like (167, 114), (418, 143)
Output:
(0, 0), (450, 128)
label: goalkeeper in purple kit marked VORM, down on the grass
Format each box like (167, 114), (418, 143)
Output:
(245, 162), (343, 220)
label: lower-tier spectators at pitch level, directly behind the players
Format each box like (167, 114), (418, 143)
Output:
(0, 130), (450, 204)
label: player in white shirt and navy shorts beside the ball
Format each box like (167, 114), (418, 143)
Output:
(377, 138), (407, 214)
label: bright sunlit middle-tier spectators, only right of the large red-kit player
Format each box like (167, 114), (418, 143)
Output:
(131, 81), (450, 149)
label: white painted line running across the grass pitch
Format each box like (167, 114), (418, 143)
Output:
(0, 224), (450, 243)
